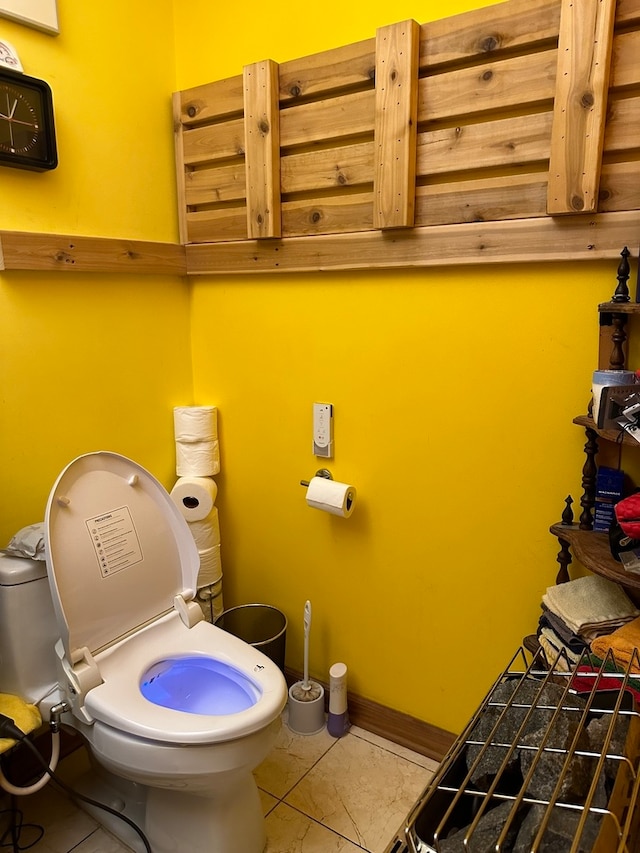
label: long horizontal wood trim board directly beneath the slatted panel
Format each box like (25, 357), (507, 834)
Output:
(186, 210), (640, 275)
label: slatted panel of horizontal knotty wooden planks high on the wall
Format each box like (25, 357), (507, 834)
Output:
(176, 0), (640, 262)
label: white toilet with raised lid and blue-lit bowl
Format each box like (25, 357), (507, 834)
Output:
(0, 452), (287, 853)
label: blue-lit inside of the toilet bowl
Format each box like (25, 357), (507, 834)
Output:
(140, 656), (261, 715)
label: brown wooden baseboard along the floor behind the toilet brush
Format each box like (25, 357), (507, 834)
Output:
(284, 667), (456, 761)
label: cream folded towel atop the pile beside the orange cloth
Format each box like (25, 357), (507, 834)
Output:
(542, 575), (640, 640)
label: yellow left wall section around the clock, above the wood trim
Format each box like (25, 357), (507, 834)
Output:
(0, 0), (177, 240)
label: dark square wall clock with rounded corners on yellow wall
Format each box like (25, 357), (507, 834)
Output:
(0, 69), (58, 172)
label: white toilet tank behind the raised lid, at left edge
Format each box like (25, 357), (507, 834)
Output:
(0, 552), (58, 704)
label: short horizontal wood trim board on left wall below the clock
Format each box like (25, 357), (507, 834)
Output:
(0, 231), (186, 276)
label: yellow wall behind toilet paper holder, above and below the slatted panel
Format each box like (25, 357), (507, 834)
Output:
(176, 0), (622, 730)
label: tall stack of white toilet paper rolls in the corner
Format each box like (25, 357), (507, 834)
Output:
(171, 406), (224, 622)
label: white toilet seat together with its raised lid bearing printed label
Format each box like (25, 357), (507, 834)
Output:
(45, 452), (286, 744)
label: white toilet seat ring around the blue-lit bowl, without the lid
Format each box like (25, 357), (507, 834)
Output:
(84, 612), (284, 744)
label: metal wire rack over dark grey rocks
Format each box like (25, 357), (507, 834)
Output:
(386, 648), (640, 853)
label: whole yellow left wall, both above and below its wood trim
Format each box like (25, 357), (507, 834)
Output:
(0, 0), (192, 532)
